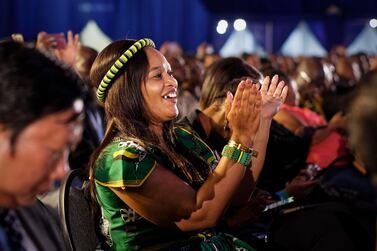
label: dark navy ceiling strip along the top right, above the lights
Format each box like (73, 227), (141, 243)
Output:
(202, 0), (377, 18)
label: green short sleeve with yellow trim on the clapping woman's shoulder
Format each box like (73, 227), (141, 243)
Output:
(94, 139), (156, 188)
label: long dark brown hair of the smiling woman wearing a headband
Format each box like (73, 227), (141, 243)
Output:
(90, 40), (210, 197)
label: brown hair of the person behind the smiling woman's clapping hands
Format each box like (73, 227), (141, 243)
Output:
(199, 57), (263, 110)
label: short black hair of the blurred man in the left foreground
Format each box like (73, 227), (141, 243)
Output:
(0, 41), (83, 147)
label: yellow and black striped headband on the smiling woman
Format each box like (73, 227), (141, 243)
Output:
(96, 38), (155, 103)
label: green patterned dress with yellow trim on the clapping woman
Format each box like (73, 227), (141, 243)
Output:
(94, 127), (252, 250)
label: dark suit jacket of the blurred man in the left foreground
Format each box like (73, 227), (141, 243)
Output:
(16, 200), (67, 251)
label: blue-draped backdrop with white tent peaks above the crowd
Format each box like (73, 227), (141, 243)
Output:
(0, 0), (377, 56)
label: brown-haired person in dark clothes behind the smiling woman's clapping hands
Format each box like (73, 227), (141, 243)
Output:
(195, 57), (309, 192)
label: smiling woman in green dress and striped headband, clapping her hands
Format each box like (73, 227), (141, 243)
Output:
(90, 39), (261, 250)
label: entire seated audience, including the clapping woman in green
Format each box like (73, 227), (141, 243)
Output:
(0, 31), (377, 251)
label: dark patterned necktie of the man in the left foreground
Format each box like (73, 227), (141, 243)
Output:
(0, 209), (25, 251)
